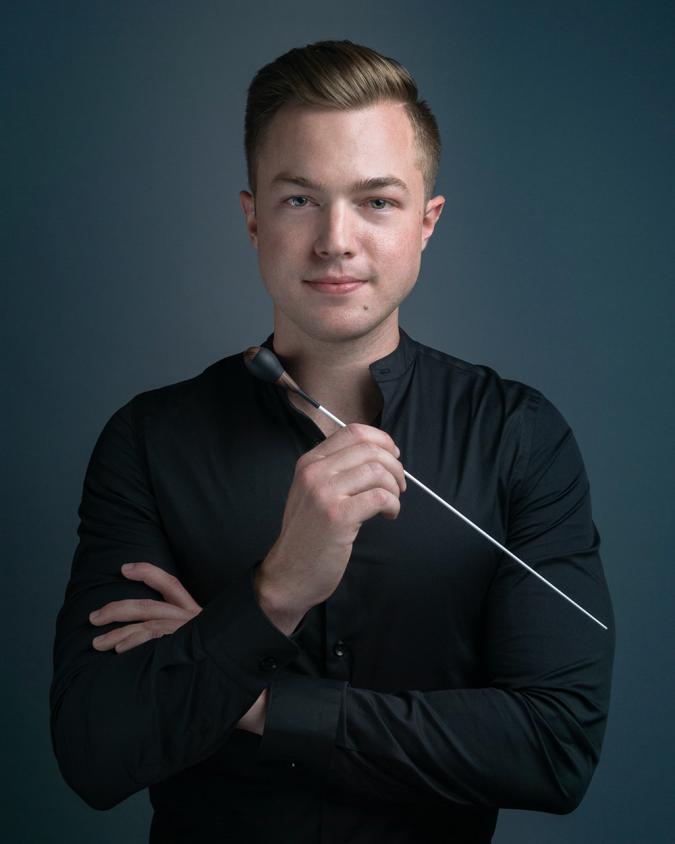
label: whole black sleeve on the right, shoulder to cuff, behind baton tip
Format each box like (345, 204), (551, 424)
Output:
(262, 393), (614, 813)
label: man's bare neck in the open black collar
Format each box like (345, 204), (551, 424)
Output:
(274, 320), (399, 435)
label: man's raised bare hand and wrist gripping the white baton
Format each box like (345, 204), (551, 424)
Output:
(255, 423), (406, 633)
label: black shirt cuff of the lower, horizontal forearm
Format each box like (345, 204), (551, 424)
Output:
(259, 675), (347, 772)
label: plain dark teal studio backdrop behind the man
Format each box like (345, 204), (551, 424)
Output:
(0, 0), (675, 844)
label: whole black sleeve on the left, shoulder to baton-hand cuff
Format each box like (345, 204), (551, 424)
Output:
(50, 402), (298, 809)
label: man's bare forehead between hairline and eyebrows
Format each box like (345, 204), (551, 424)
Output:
(257, 103), (423, 195)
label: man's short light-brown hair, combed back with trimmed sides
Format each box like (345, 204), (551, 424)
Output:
(244, 41), (441, 199)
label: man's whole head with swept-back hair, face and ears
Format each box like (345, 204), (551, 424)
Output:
(240, 42), (444, 346)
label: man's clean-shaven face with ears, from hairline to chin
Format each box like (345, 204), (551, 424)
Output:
(240, 103), (444, 342)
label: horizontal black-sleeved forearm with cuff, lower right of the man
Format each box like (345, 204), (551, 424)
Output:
(261, 678), (605, 812)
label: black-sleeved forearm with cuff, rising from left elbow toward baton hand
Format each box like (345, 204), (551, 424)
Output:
(52, 582), (297, 808)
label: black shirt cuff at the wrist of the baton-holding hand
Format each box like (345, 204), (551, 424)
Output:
(194, 568), (300, 694)
